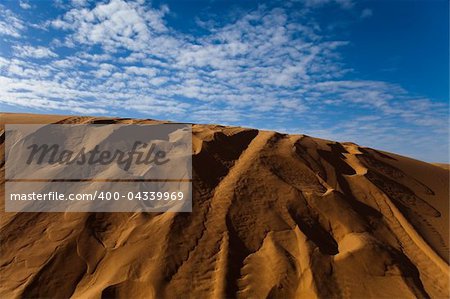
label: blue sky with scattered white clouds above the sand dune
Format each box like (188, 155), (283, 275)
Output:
(0, 0), (449, 162)
